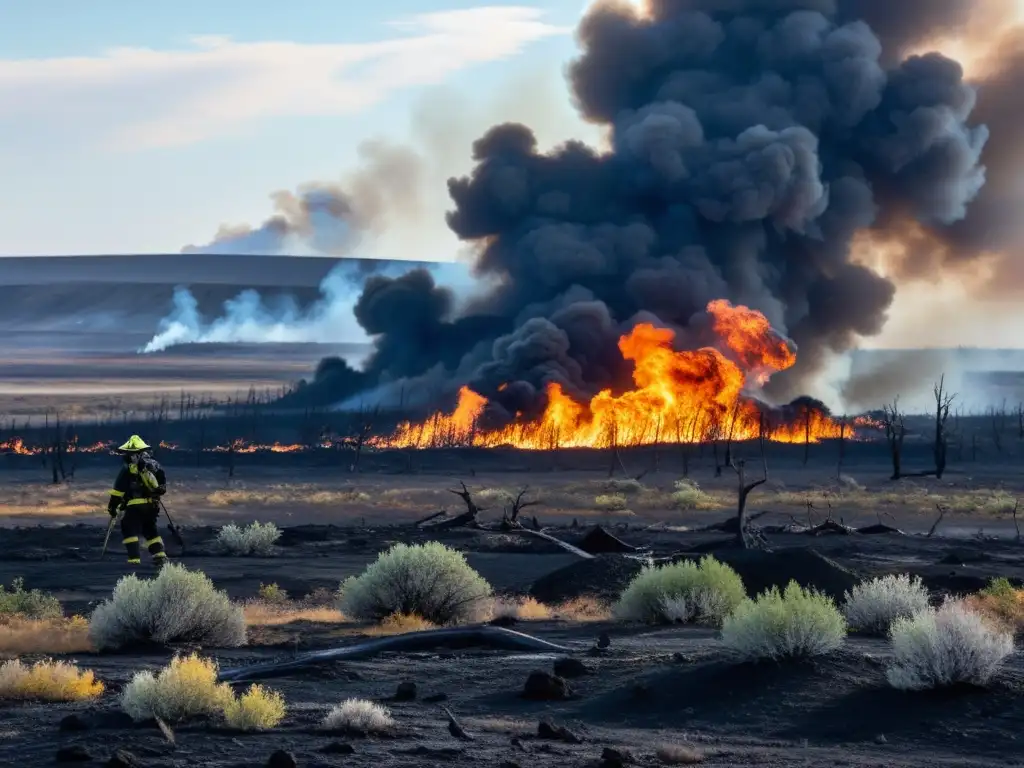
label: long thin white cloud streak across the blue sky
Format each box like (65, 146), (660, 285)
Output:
(0, 6), (570, 148)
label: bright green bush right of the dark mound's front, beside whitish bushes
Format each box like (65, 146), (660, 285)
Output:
(722, 582), (847, 660)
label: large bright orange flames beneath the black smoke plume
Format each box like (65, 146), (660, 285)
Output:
(385, 300), (854, 450)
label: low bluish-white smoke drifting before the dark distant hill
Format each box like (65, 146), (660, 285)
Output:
(138, 262), (478, 353)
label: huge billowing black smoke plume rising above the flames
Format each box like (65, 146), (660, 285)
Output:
(305, 0), (999, 415)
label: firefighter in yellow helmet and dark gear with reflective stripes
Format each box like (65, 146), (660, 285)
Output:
(106, 434), (167, 570)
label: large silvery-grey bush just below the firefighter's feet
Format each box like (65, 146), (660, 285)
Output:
(89, 563), (246, 650)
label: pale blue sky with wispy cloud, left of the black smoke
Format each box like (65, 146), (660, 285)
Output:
(0, 0), (596, 259)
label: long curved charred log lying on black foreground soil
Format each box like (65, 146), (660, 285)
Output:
(218, 627), (571, 683)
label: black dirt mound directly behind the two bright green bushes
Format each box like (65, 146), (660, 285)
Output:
(677, 547), (861, 600)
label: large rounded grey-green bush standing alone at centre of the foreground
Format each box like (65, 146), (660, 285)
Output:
(338, 542), (492, 625)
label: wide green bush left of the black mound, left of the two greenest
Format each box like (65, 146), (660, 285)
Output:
(612, 556), (746, 625)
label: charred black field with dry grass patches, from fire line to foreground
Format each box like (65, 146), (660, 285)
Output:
(0, 442), (1024, 766)
